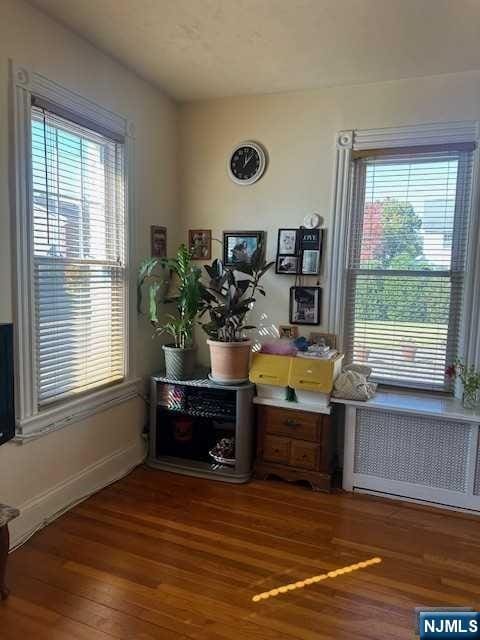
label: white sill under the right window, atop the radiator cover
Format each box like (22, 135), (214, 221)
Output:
(331, 391), (480, 424)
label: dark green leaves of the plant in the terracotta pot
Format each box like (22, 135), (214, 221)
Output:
(199, 246), (274, 342)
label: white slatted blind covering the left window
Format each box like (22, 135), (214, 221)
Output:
(32, 106), (127, 406)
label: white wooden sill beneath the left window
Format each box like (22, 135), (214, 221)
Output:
(14, 378), (140, 444)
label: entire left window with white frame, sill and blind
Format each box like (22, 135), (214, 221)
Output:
(10, 62), (136, 439)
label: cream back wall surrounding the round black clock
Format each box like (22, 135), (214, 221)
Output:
(180, 72), (480, 361)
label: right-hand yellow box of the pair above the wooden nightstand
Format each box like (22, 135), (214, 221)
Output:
(288, 354), (343, 393)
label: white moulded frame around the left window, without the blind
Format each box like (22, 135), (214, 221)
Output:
(10, 61), (139, 440)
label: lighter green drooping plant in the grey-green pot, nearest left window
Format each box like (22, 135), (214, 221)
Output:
(138, 244), (203, 380)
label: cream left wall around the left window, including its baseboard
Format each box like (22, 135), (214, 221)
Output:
(0, 0), (179, 539)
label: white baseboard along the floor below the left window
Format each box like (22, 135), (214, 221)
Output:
(10, 438), (145, 548)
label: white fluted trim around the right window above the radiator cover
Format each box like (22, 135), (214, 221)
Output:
(326, 121), (480, 397)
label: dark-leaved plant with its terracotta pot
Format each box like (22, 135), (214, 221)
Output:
(200, 247), (274, 384)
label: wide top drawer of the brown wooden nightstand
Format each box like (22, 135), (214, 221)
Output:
(263, 407), (322, 442)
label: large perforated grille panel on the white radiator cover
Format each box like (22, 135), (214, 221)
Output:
(354, 409), (470, 493)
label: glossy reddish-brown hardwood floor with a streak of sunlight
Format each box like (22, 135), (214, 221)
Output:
(0, 468), (480, 640)
